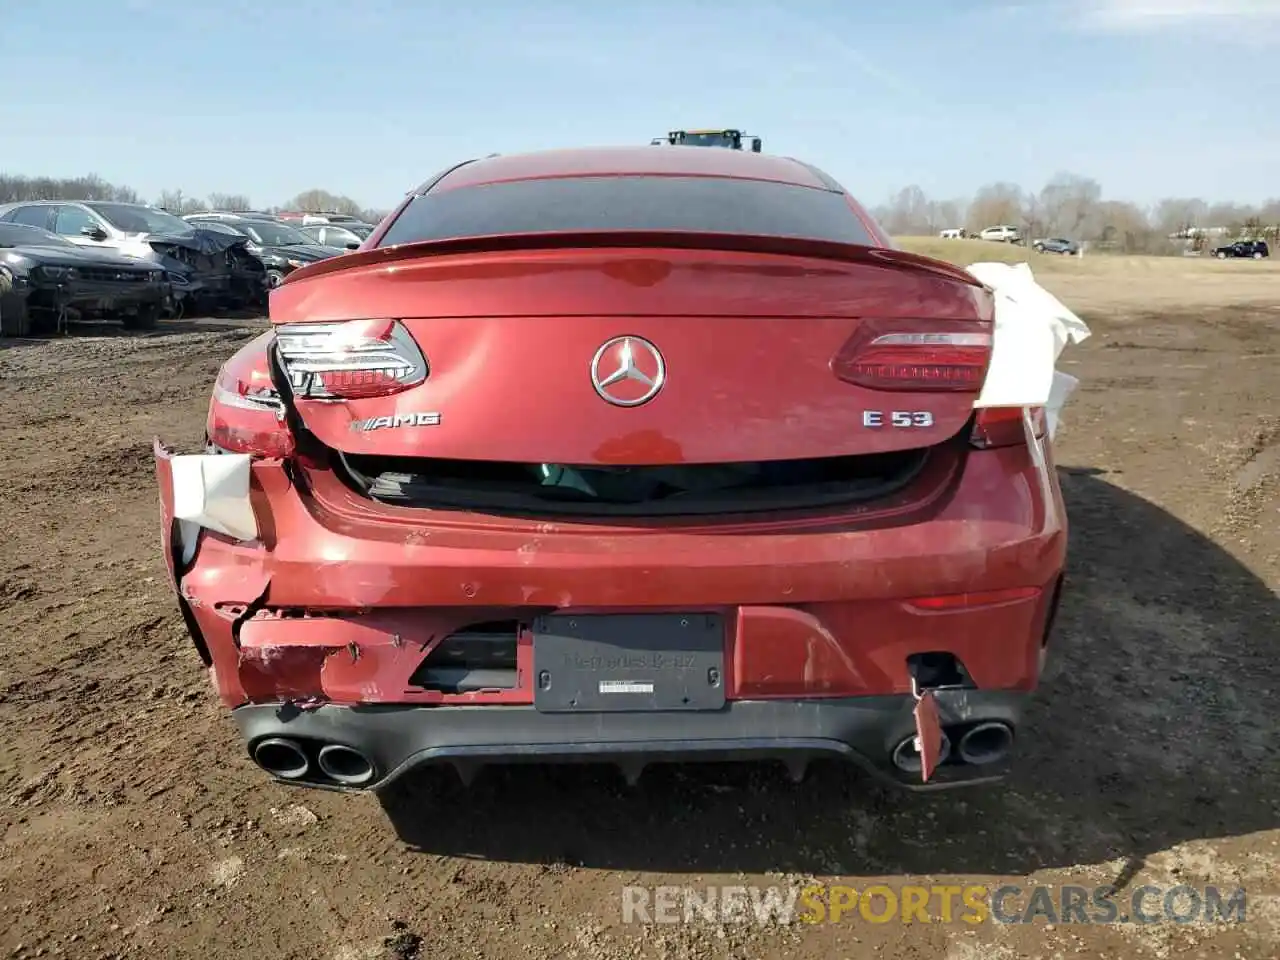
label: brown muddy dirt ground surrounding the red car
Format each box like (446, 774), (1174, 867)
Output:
(0, 262), (1280, 960)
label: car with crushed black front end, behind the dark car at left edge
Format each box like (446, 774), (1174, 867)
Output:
(0, 200), (266, 316)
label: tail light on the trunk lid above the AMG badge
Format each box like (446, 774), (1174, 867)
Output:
(275, 320), (428, 399)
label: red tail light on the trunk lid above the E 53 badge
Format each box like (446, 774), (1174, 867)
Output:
(831, 321), (991, 393)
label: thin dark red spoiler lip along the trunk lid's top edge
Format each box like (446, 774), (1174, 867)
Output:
(278, 230), (986, 300)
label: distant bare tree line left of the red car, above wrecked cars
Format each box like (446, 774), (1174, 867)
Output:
(0, 174), (387, 223)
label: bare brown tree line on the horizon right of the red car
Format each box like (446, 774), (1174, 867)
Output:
(873, 173), (1280, 253)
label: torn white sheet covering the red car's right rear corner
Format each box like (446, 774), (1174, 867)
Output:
(968, 257), (1089, 436)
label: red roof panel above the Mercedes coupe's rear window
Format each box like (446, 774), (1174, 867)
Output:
(417, 146), (840, 193)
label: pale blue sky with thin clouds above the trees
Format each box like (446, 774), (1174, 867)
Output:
(0, 0), (1280, 207)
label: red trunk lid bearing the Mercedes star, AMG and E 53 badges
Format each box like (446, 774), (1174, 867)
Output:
(271, 241), (991, 465)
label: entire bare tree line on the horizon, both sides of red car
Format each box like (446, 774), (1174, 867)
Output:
(0, 173), (1280, 253)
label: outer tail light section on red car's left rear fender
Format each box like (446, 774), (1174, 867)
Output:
(206, 357), (294, 458)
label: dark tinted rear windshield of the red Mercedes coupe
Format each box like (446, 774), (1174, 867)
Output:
(380, 177), (874, 247)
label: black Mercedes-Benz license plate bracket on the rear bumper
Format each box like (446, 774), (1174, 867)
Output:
(532, 613), (724, 713)
